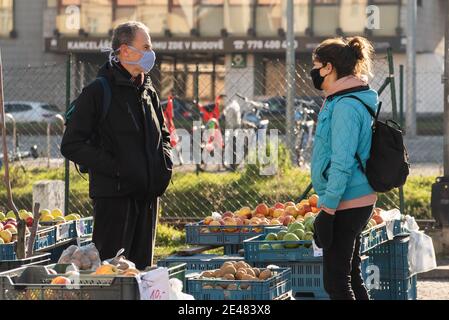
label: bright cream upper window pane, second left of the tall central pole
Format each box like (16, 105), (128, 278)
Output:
(224, 0), (252, 35)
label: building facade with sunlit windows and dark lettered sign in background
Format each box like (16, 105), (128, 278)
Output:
(0, 0), (446, 112)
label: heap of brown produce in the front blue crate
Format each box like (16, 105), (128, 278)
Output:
(199, 261), (273, 290)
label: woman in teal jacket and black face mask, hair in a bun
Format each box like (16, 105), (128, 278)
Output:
(311, 37), (378, 300)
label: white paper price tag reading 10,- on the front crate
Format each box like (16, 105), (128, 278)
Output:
(138, 268), (170, 300)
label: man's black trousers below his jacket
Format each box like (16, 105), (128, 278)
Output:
(92, 197), (158, 270)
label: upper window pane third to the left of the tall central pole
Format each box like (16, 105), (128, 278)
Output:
(198, 0), (224, 37)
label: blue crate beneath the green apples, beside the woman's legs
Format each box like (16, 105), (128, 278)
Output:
(254, 258), (329, 300)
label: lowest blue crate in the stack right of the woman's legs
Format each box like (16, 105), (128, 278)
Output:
(370, 275), (417, 300)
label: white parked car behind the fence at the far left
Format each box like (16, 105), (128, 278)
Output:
(5, 101), (62, 122)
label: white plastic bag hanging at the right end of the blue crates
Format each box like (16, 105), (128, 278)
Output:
(408, 230), (437, 275)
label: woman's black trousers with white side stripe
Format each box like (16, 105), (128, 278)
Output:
(320, 206), (373, 300)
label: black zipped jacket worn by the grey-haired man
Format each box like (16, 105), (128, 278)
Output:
(61, 63), (173, 198)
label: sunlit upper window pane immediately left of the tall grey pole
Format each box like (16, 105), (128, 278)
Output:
(256, 0), (280, 36)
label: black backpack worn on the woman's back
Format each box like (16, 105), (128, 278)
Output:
(344, 96), (410, 193)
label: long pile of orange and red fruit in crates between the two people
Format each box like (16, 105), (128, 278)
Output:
(201, 195), (320, 233)
